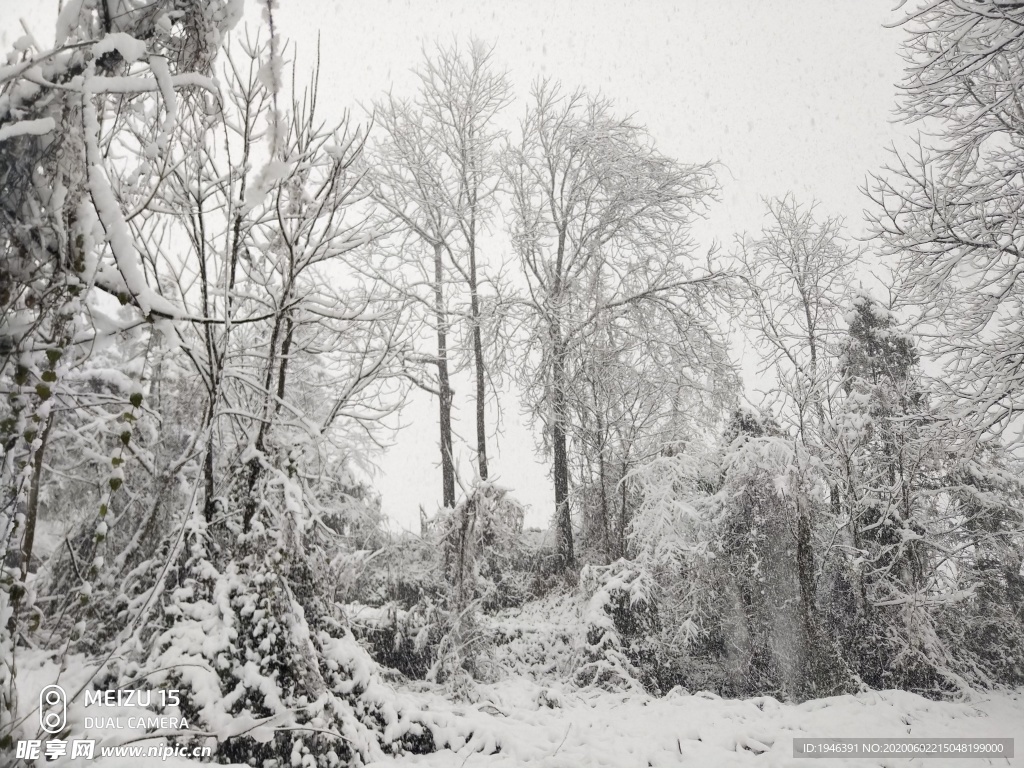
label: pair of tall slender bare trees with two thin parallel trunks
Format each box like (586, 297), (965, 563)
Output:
(368, 41), (510, 508)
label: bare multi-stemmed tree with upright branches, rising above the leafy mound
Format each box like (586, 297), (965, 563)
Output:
(133, 40), (404, 530)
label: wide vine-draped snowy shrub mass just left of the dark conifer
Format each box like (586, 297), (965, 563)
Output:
(631, 411), (849, 698)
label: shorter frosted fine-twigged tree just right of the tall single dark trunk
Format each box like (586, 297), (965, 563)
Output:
(568, 296), (735, 561)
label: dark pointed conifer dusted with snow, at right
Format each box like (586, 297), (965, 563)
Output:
(829, 294), (974, 693)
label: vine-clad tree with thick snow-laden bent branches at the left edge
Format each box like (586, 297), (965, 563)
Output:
(0, 0), (241, 736)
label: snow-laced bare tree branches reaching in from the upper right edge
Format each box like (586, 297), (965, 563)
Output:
(868, 0), (1024, 443)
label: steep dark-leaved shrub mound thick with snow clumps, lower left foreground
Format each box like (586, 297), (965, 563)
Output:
(143, 507), (434, 767)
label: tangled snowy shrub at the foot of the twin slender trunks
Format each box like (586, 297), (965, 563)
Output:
(344, 482), (531, 689)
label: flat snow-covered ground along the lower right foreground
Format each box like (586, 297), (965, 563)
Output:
(374, 679), (1024, 768)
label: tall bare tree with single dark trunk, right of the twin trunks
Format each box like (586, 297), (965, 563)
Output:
(505, 82), (719, 567)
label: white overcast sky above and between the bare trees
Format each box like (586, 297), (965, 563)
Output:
(0, 0), (909, 527)
